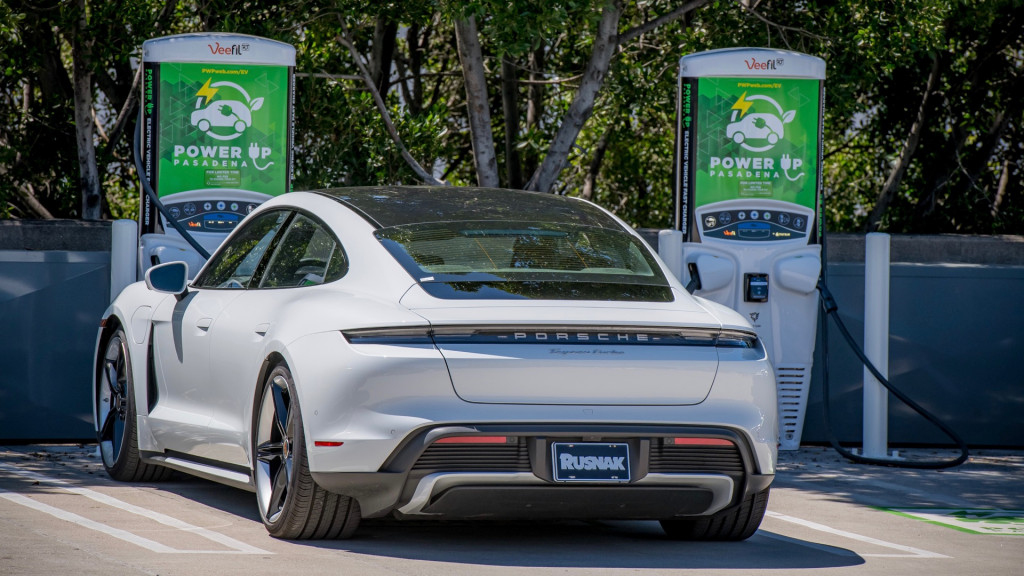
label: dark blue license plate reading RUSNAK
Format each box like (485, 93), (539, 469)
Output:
(551, 443), (630, 482)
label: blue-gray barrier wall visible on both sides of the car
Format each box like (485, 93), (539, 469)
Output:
(0, 220), (1024, 448)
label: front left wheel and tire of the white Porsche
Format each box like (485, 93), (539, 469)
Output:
(94, 329), (171, 482)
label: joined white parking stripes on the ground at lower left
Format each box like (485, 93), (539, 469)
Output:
(0, 462), (273, 554)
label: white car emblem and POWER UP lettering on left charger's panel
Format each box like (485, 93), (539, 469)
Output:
(180, 78), (273, 170)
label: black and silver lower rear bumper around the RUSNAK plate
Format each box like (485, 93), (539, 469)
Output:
(312, 424), (774, 520)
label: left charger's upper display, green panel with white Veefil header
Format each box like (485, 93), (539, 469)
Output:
(142, 34), (295, 197)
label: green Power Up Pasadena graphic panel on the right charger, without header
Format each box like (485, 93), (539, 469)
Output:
(694, 78), (820, 210)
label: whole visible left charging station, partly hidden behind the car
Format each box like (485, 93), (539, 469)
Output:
(133, 32), (295, 273)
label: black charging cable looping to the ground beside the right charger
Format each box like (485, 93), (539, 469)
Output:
(817, 233), (970, 469)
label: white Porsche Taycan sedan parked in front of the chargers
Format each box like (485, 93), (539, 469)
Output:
(94, 188), (777, 540)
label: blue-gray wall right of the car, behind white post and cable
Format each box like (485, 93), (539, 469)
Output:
(803, 231), (1024, 447)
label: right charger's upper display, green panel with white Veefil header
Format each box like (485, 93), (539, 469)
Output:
(677, 48), (824, 235)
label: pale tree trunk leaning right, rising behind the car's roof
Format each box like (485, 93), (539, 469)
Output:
(526, 0), (623, 192)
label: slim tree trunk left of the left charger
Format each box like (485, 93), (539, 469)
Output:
(72, 0), (101, 220)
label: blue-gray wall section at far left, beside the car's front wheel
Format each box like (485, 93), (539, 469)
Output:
(0, 220), (111, 441)
